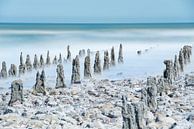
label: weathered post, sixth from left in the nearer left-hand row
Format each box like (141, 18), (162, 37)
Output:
(94, 51), (102, 74)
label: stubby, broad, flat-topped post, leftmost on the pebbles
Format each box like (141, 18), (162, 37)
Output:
(8, 80), (24, 106)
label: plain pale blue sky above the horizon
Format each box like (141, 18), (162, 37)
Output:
(0, 0), (194, 23)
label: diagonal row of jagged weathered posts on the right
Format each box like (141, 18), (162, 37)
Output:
(122, 45), (192, 129)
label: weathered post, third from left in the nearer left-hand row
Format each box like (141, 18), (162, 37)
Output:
(55, 64), (66, 88)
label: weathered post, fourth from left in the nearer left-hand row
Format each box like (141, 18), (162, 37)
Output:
(71, 56), (81, 84)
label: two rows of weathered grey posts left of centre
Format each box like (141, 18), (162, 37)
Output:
(6, 44), (123, 105)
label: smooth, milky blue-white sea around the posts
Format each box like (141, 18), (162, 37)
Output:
(0, 24), (194, 88)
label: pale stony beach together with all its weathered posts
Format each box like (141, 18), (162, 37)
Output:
(0, 44), (194, 129)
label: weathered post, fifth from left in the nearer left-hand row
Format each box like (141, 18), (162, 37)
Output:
(84, 56), (92, 78)
